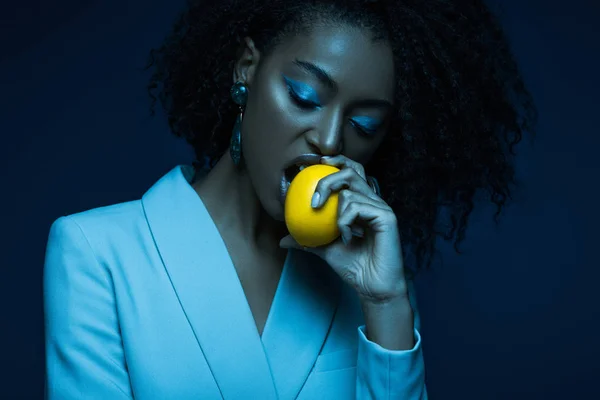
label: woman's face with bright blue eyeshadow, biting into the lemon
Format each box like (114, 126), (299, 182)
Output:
(234, 26), (394, 221)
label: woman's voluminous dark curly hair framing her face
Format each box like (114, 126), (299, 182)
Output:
(148, 0), (537, 272)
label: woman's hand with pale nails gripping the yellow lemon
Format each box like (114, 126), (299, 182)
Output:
(280, 155), (408, 304)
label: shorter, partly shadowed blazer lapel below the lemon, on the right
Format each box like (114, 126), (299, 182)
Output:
(262, 250), (341, 399)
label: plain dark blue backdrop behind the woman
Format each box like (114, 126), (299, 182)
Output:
(0, 0), (600, 400)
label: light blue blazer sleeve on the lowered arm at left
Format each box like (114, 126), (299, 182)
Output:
(44, 217), (133, 400)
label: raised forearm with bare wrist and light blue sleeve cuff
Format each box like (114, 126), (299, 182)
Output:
(356, 283), (427, 400)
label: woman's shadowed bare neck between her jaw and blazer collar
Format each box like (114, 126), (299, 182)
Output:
(192, 153), (287, 253)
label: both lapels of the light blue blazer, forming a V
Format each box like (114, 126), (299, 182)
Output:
(142, 166), (340, 400)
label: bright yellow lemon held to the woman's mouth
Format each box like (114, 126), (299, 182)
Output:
(285, 164), (340, 247)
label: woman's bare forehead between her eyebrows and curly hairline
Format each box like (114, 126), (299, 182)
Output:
(273, 25), (394, 100)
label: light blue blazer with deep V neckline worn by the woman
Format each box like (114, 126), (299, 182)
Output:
(44, 166), (427, 400)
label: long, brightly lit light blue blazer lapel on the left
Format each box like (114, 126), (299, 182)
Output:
(142, 167), (278, 400)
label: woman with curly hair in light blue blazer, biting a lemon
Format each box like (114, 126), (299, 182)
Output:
(44, 0), (533, 399)
